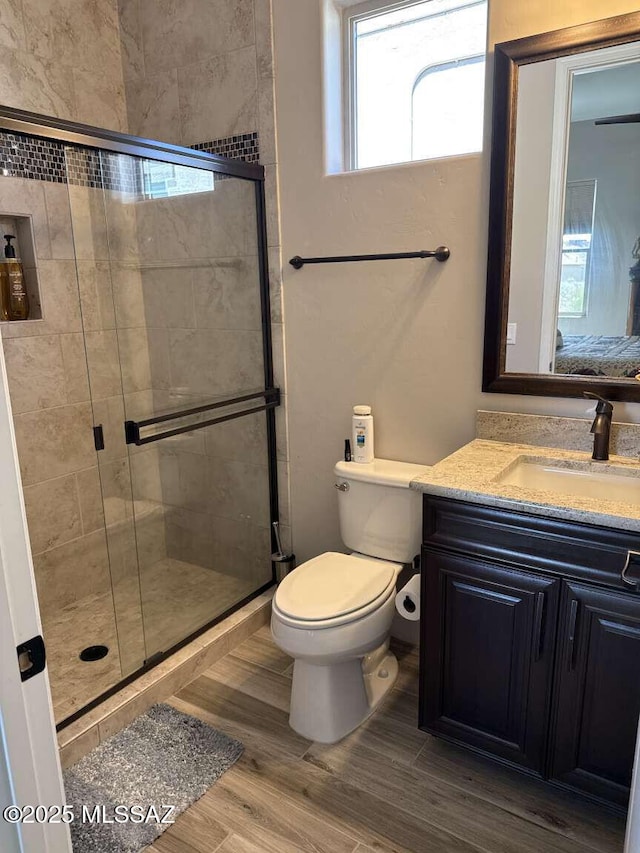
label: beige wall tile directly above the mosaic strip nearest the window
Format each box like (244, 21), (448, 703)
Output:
(178, 47), (258, 145)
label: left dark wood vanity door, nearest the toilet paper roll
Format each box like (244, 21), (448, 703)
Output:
(420, 549), (560, 774)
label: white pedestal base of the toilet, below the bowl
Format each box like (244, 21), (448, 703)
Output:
(289, 641), (398, 743)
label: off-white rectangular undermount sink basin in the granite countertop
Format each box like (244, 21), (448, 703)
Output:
(495, 456), (640, 505)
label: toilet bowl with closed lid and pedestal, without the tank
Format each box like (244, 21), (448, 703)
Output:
(271, 552), (402, 743)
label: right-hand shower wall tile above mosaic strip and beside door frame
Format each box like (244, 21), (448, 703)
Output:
(120, 0), (291, 545)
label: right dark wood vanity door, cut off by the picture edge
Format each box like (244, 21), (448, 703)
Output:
(550, 582), (640, 805)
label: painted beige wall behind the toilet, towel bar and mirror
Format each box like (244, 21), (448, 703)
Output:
(273, 0), (640, 560)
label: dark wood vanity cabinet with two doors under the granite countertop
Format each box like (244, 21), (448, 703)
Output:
(420, 495), (640, 806)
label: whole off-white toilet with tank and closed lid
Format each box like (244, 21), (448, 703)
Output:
(271, 459), (427, 743)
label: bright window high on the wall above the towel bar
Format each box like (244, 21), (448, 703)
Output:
(343, 0), (487, 169)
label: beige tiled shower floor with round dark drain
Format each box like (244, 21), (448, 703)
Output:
(43, 558), (268, 722)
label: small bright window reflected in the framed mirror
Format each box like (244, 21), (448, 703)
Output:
(558, 181), (596, 317)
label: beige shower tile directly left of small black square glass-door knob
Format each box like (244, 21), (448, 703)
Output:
(14, 403), (96, 486)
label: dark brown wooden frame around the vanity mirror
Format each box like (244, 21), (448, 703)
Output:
(482, 12), (640, 402)
